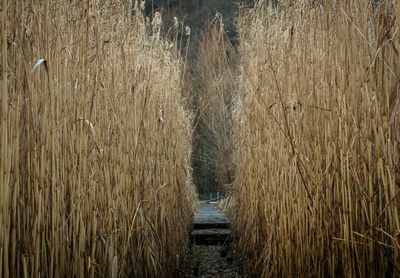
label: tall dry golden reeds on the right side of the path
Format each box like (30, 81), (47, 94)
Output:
(229, 0), (400, 277)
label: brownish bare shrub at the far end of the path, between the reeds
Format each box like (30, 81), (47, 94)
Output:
(193, 13), (237, 194)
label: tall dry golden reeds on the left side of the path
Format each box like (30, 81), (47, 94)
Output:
(0, 0), (195, 277)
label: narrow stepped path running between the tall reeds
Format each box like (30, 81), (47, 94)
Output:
(190, 202), (239, 278)
